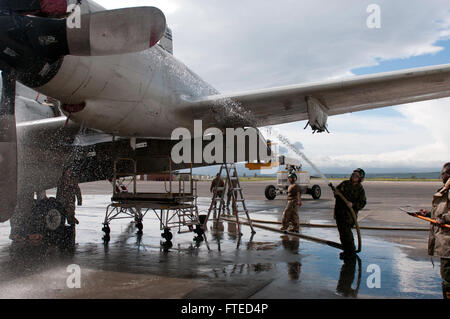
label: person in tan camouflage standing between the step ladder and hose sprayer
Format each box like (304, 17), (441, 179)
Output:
(280, 173), (302, 233)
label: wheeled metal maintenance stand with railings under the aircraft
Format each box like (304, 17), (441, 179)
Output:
(102, 156), (204, 242)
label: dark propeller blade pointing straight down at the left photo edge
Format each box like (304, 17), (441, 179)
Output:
(0, 71), (17, 222)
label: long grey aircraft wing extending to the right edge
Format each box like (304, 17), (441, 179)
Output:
(181, 64), (450, 130)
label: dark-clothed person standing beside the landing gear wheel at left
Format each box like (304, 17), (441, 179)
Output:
(56, 168), (82, 225)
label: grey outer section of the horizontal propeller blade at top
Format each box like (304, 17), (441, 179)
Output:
(67, 7), (166, 56)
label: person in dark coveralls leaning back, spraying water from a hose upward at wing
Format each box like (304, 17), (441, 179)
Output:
(334, 168), (366, 259)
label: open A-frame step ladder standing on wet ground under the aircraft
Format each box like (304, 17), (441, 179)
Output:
(203, 163), (256, 235)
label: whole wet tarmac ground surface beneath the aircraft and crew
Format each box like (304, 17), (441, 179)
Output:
(0, 182), (441, 299)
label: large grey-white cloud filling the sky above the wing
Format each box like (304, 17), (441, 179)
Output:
(92, 0), (450, 91)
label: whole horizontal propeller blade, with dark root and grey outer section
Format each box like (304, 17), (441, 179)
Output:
(0, 5), (166, 71)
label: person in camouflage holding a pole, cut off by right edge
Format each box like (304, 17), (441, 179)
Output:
(419, 162), (450, 299)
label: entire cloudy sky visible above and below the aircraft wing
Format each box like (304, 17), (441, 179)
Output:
(97, 0), (450, 172)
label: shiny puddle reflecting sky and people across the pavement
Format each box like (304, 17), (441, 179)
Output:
(0, 195), (441, 299)
